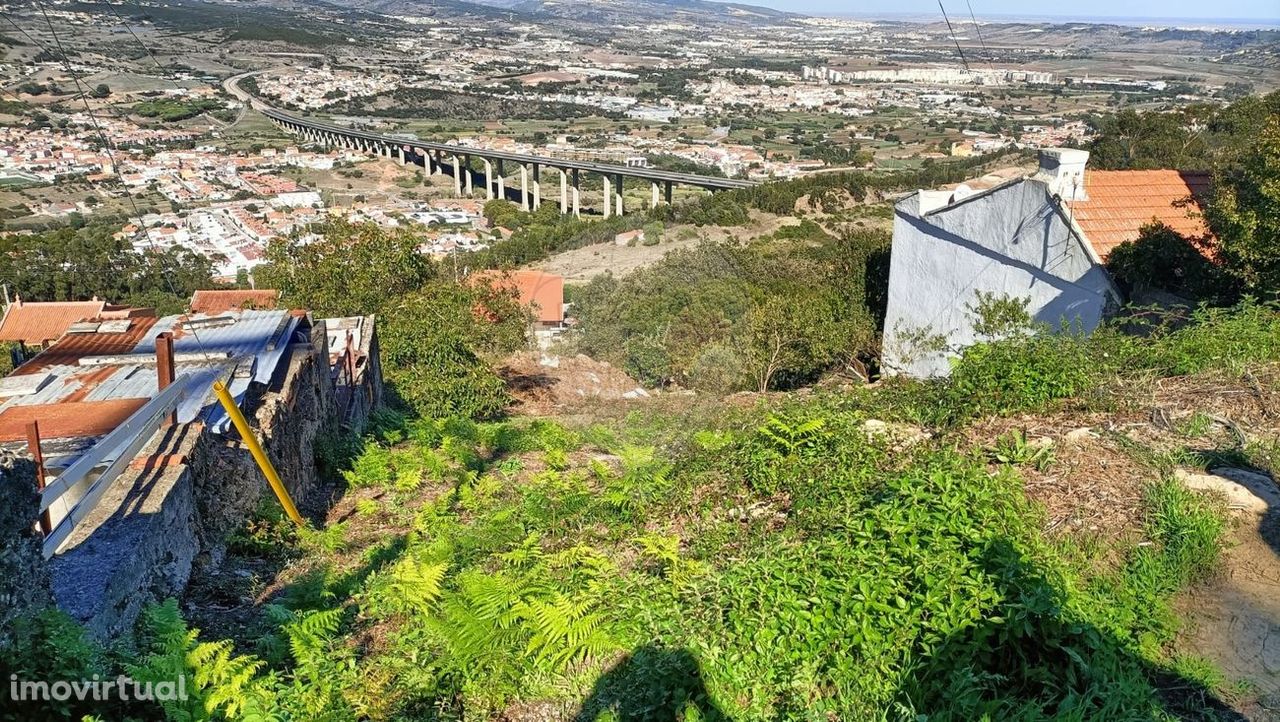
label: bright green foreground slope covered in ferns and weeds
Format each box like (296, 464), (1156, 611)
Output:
(145, 302), (1280, 719)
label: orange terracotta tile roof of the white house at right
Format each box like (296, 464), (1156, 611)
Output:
(1070, 170), (1210, 260)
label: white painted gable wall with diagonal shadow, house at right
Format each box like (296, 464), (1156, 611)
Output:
(883, 179), (1116, 378)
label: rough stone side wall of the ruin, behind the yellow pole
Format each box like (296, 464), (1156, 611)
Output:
(48, 318), (358, 640)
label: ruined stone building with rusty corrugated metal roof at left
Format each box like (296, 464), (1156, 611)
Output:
(0, 296), (381, 639)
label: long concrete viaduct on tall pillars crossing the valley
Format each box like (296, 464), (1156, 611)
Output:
(262, 101), (755, 218)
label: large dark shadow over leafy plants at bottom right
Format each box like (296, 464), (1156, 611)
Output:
(899, 543), (1245, 722)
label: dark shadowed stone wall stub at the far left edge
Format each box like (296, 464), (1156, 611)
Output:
(0, 451), (52, 649)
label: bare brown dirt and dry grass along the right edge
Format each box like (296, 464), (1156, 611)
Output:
(965, 366), (1280, 722)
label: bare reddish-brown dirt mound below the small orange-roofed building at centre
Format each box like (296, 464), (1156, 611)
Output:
(498, 352), (650, 416)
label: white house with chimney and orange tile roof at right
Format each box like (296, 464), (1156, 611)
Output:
(882, 148), (1207, 378)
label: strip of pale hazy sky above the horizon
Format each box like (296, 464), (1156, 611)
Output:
(739, 0), (1280, 24)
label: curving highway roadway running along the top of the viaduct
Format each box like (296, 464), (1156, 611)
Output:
(224, 70), (756, 191)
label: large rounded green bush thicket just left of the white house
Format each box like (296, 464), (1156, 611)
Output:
(575, 233), (887, 392)
